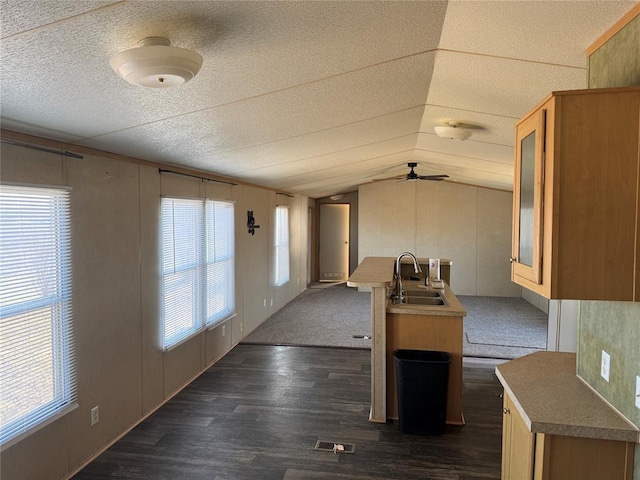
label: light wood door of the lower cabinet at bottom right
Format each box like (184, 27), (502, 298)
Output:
(502, 393), (535, 480)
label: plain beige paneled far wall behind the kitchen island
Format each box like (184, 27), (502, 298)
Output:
(358, 177), (520, 297)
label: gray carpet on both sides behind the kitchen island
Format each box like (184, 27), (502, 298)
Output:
(242, 283), (547, 359)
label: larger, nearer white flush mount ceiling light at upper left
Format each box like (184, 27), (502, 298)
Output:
(111, 37), (202, 88)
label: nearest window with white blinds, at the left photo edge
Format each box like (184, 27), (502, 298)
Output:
(0, 185), (76, 444)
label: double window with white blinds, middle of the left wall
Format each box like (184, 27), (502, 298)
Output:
(162, 198), (235, 349)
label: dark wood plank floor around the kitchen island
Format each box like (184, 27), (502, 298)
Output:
(74, 345), (502, 480)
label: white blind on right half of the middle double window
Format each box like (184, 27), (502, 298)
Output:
(206, 200), (235, 326)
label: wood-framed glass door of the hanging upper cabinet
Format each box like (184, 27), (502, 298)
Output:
(511, 109), (545, 284)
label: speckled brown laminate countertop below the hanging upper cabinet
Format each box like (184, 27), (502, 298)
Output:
(496, 352), (640, 442)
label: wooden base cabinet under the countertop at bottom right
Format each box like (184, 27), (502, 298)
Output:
(502, 393), (634, 480)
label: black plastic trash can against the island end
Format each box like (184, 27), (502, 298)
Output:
(393, 350), (451, 435)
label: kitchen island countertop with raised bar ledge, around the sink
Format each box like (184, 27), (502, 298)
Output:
(347, 257), (467, 317)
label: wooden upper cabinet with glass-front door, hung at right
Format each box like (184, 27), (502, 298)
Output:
(511, 87), (640, 301)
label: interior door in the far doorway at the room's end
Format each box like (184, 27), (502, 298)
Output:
(319, 204), (349, 282)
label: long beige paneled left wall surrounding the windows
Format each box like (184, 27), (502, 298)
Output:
(0, 145), (308, 480)
